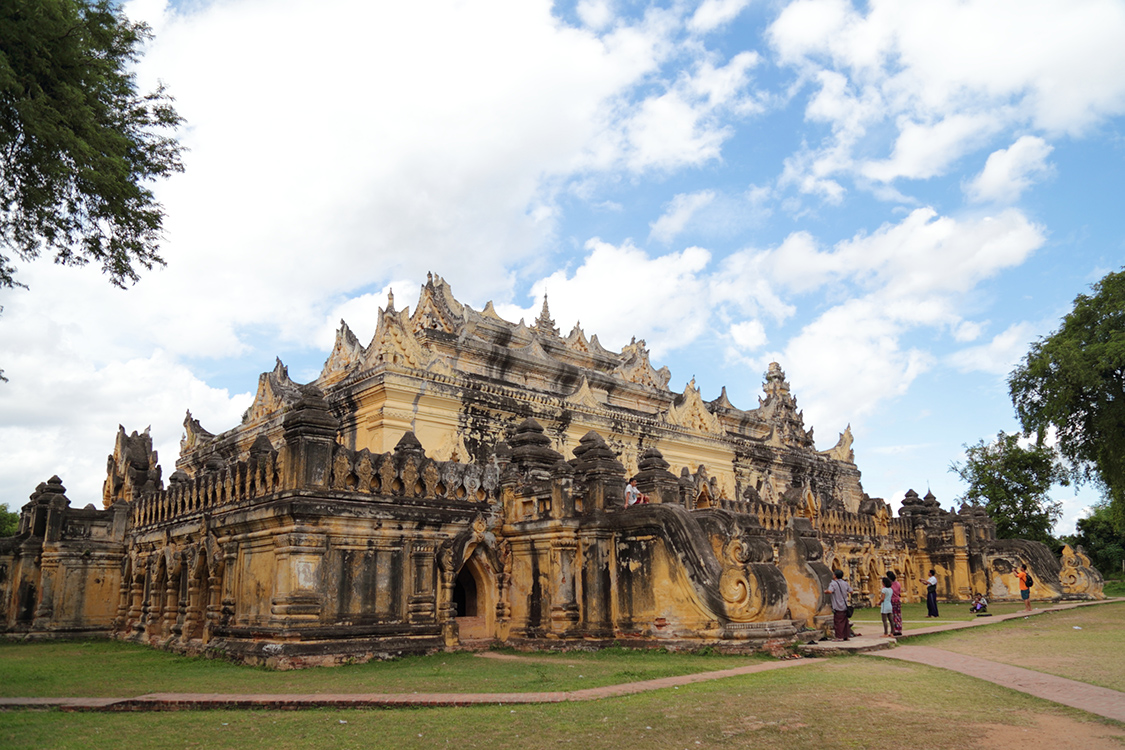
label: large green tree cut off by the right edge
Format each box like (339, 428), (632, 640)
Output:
(1008, 271), (1125, 532)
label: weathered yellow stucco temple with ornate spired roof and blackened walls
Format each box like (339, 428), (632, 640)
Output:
(0, 277), (1101, 666)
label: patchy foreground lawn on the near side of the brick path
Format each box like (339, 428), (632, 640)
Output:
(0, 657), (1125, 750)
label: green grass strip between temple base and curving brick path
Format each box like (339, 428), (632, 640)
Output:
(0, 641), (768, 697)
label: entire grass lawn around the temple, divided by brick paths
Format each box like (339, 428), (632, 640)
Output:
(0, 603), (1125, 750)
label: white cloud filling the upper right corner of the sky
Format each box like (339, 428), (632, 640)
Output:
(767, 0), (1125, 197)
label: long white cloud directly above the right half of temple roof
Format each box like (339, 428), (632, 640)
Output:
(498, 202), (1044, 440)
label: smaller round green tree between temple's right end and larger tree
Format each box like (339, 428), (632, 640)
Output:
(950, 432), (1069, 545)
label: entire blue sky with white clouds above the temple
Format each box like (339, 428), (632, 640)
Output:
(0, 0), (1125, 533)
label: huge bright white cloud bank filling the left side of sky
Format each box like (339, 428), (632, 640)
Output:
(0, 0), (774, 510)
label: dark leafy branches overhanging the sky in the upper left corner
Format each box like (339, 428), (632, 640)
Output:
(0, 0), (182, 288)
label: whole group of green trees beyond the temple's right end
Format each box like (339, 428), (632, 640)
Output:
(950, 266), (1125, 576)
